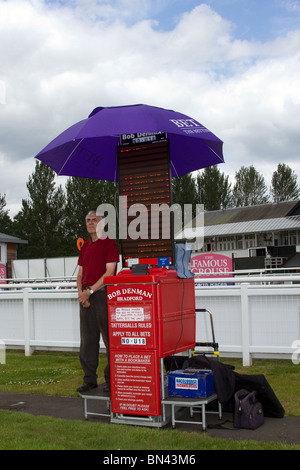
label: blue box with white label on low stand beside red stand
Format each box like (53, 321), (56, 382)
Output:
(168, 369), (214, 398)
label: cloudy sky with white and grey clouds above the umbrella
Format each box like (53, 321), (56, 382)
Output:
(0, 0), (300, 217)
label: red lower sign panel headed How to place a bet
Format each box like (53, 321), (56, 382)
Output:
(110, 350), (161, 416)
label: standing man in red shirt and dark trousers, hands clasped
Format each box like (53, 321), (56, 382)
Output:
(77, 211), (119, 393)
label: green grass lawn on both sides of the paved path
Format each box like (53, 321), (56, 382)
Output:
(0, 351), (300, 451)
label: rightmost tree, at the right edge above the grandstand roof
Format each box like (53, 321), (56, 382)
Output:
(270, 163), (300, 202)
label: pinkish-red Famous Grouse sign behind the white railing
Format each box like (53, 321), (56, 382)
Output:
(191, 253), (232, 277)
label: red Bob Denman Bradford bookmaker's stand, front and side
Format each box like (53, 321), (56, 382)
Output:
(105, 268), (195, 417)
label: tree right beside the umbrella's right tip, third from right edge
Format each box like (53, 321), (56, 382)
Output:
(197, 166), (232, 211)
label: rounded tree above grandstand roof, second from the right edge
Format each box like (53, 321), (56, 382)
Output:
(233, 166), (269, 207)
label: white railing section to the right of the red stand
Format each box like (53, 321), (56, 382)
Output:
(196, 275), (300, 366)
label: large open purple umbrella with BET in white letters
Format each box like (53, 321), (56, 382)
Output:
(36, 104), (224, 181)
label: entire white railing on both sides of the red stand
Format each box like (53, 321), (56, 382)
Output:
(0, 274), (300, 366)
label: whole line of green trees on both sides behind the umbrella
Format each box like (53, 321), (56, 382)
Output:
(0, 161), (300, 258)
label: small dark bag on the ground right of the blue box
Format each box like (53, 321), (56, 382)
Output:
(234, 390), (264, 429)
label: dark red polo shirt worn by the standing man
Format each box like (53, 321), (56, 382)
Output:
(78, 237), (119, 286)
